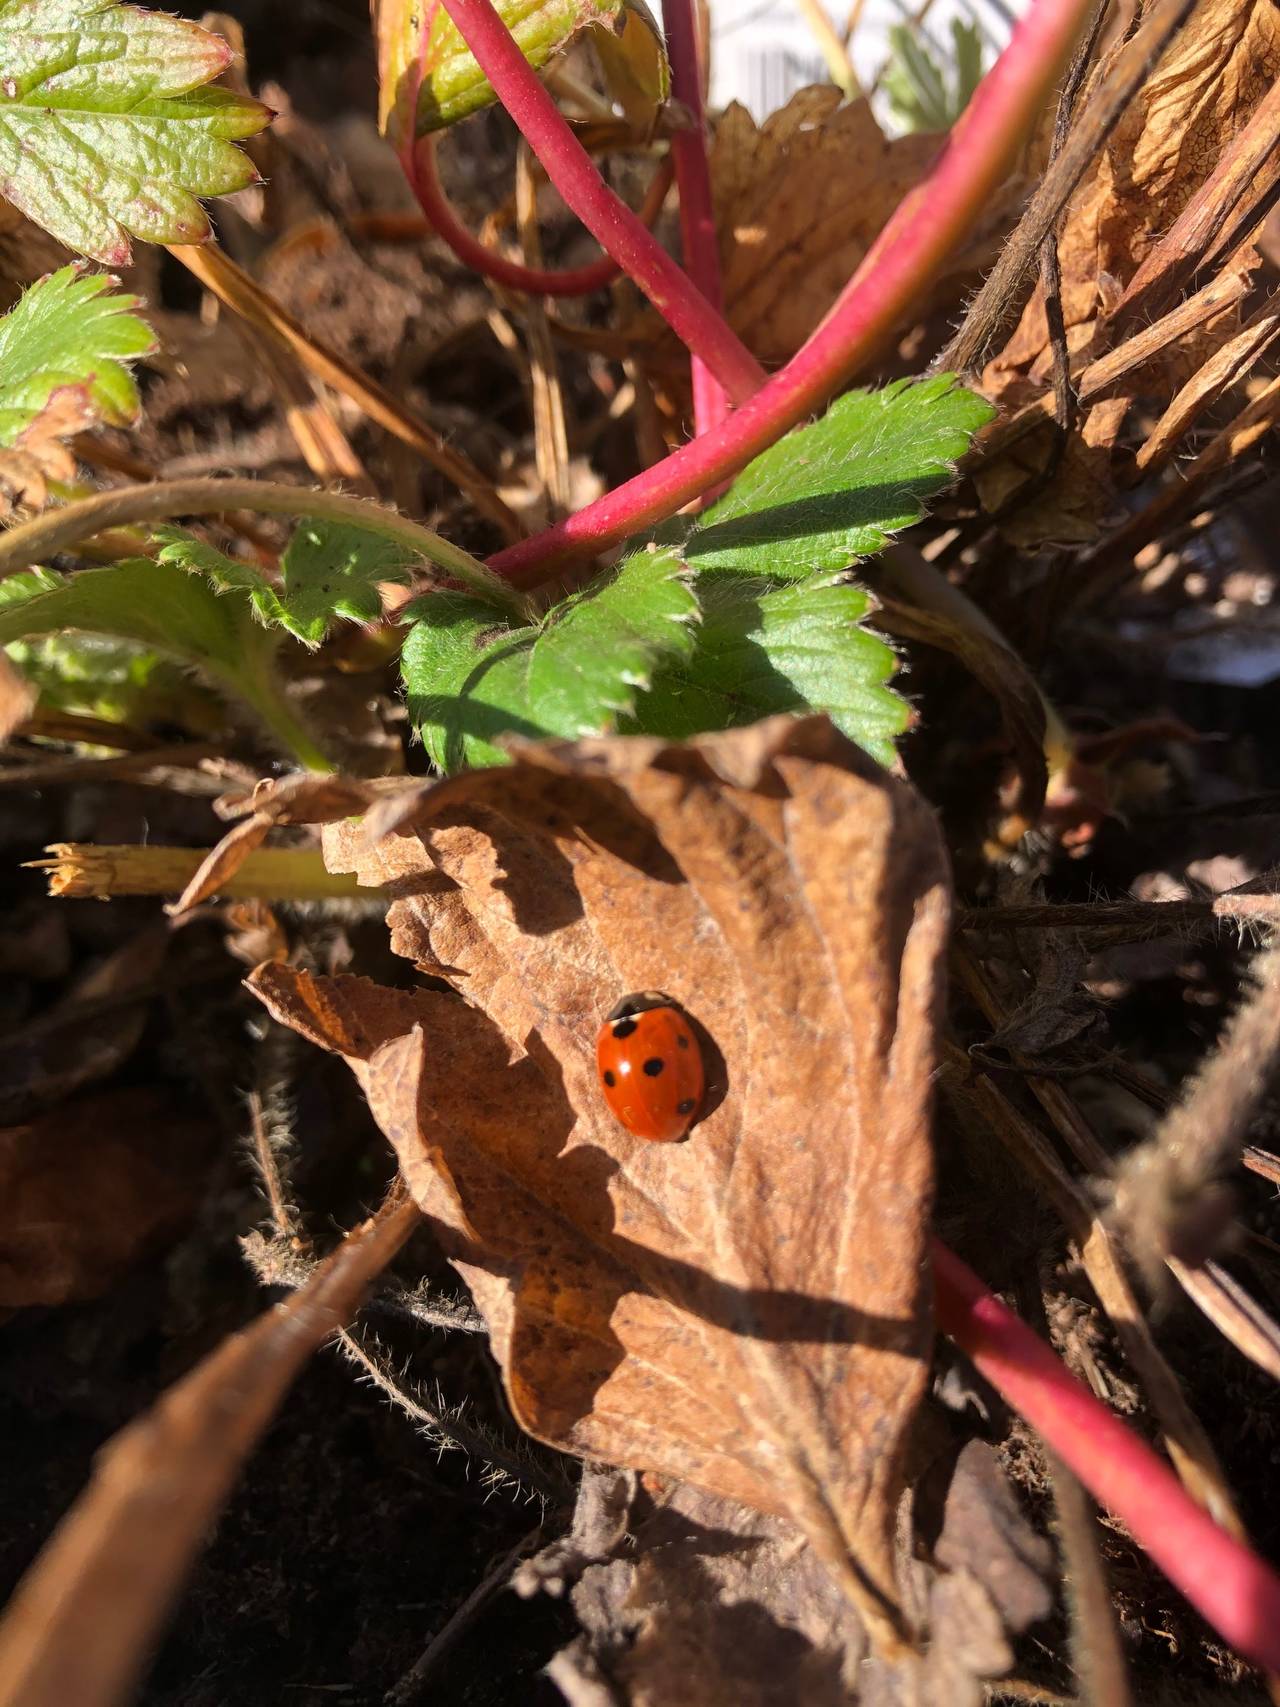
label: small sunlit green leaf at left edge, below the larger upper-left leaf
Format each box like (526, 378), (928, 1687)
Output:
(0, 266), (155, 446)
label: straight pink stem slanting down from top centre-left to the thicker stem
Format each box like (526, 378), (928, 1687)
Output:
(444, 0), (763, 401)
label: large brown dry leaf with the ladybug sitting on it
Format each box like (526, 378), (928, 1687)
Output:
(251, 717), (947, 1646)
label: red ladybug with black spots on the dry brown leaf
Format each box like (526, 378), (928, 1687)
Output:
(596, 990), (707, 1144)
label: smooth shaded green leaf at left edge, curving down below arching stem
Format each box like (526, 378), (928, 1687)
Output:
(0, 558), (328, 768)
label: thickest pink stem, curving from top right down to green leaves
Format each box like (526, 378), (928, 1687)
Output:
(488, 0), (1092, 580)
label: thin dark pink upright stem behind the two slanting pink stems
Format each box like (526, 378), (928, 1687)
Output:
(662, 0), (727, 434)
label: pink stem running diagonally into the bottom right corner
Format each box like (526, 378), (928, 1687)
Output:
(934, 1239), (1280, 1673)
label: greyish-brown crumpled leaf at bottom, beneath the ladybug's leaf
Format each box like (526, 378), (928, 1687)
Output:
(512, 1441), (1053, 1707)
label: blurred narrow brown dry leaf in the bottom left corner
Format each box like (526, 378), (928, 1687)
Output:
(0, 1193), (418, 1707)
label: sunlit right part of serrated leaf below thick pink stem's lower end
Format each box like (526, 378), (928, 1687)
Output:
(527, 550), (698, 737)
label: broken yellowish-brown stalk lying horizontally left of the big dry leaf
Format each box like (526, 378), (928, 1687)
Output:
(27, 842), (370, 901)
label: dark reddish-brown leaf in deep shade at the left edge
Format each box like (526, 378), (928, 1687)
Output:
(0, 1089), (210, 1309)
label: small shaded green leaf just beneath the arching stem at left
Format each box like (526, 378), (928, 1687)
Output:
(157, 519), (416, 647)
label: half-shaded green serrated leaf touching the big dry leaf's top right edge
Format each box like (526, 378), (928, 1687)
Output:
(630, 574), (910, 765)
